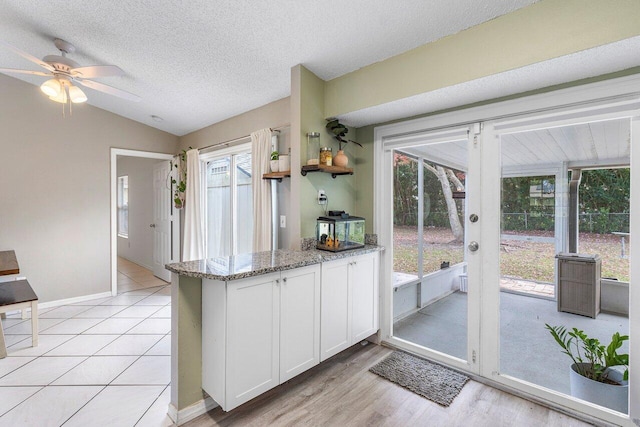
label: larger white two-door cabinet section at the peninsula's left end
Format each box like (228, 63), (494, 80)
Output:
(202, 265), (320, 411)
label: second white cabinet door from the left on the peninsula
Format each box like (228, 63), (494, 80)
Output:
(280, 265), (320, 383)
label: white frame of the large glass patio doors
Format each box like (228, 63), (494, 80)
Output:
(373, 75), (640, 426)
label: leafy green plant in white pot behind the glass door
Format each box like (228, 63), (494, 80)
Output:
(545, 324), (629, 414)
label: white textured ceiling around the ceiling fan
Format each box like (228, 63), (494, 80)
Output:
(0, 0), (535, 135)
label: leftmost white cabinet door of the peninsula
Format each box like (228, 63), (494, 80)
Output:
(224, 273), (280, 411)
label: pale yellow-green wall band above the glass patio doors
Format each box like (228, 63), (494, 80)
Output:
(324, 0), (640, 117)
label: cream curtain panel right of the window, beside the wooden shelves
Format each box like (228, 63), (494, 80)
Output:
(251, 128), (272, 252)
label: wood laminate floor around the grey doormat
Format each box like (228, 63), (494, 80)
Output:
(185, 344), (589, 427)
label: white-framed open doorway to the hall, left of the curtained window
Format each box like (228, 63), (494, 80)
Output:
(111, 148), (180, 295)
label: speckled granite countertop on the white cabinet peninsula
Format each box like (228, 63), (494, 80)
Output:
(165, 245), (384, 281)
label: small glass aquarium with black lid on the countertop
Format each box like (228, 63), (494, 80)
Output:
(316, 211), (364, 252)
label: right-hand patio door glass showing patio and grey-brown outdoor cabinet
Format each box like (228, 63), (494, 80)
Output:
(498, 119), (630, 413)
